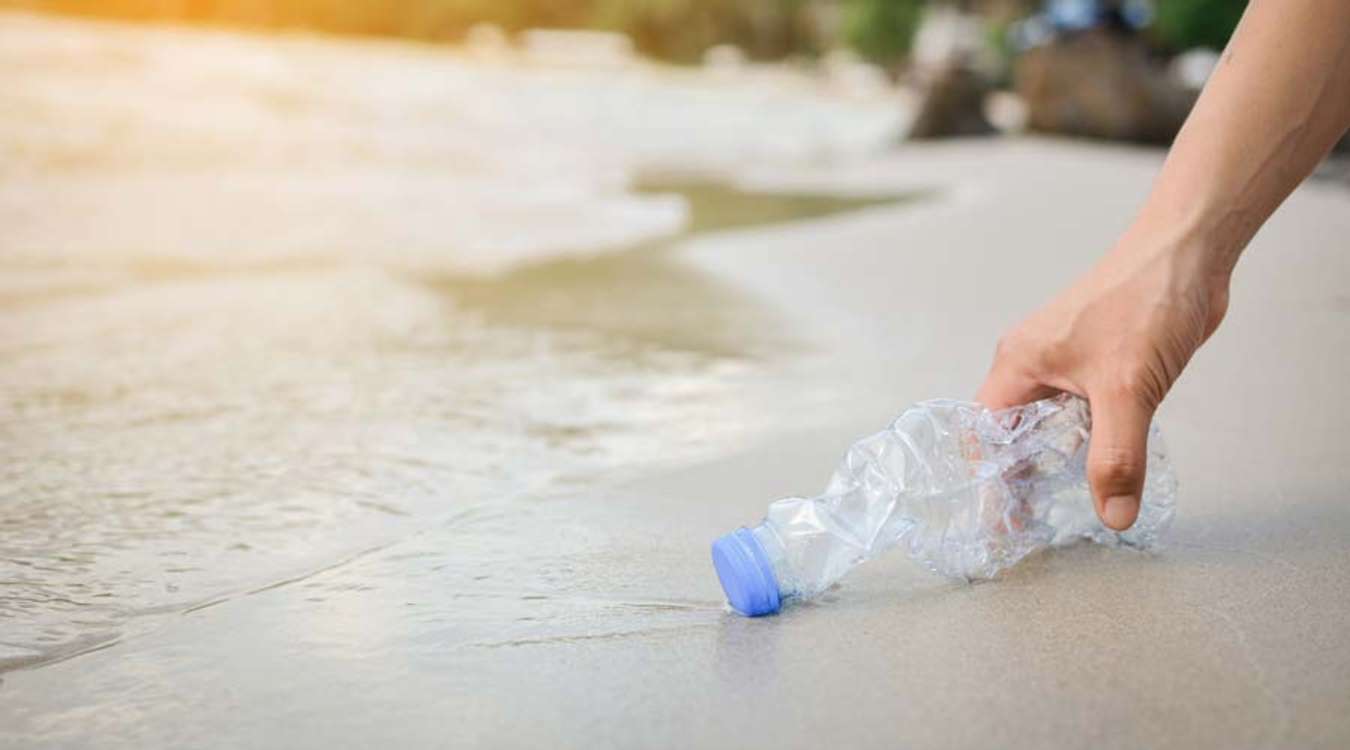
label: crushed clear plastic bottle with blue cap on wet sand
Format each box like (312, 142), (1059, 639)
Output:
(713, 394), (1177, 616)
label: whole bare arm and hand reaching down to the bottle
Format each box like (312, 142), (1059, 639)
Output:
(976, 0), (1350, 530)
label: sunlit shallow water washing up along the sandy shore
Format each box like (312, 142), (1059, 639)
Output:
(0, 15), (918, 670)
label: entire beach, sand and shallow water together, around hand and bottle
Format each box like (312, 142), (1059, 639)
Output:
(0, 16), (1350, 747)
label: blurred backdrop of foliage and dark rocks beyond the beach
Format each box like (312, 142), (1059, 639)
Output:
(0, 0), (1245, 143)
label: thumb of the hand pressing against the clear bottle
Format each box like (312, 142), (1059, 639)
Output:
(1088, 393), (1156, 531)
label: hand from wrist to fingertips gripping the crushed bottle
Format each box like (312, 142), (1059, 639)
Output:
(976, 229), (1231, 530)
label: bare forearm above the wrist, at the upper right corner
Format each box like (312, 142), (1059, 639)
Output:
(1141, 0), (1350, 270)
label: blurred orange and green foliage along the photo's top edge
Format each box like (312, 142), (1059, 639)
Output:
(0, 0), (1246, 66)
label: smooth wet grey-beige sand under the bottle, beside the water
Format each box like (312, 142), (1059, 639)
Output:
(0, 11), (1350, 747)
